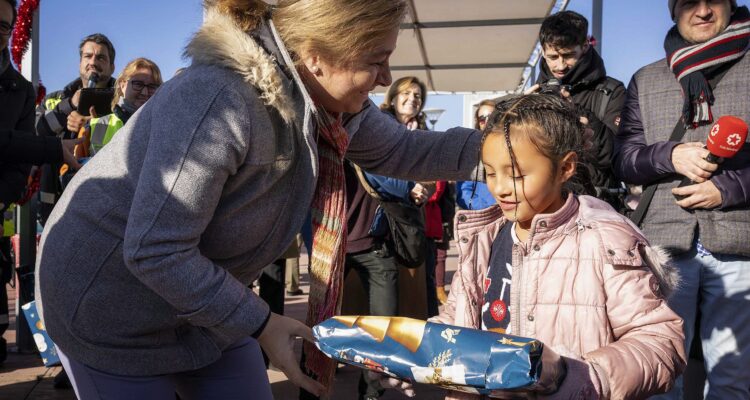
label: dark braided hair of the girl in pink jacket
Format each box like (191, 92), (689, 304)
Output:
(480, 93), (596, 194)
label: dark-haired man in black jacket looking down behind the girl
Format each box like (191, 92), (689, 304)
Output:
(527, 11), (625, 211)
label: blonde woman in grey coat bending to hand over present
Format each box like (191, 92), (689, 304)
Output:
(37, 0), (481, 399)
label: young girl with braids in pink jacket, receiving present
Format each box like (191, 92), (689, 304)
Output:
(433, 94), (685, 399)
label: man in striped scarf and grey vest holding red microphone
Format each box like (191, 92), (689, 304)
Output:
(614, 0), (750, 400)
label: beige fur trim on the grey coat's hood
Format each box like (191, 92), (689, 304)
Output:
(185, 9), (294, 123)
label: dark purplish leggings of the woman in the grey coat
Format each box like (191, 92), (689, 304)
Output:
(58, 338), (273, 400)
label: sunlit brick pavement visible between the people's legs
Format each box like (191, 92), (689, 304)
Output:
(0, 251), (456, 400)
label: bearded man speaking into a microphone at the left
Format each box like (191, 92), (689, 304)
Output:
(36, 33), (115, 223)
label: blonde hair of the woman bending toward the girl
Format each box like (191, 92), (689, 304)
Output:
(204, 0), (407, 65)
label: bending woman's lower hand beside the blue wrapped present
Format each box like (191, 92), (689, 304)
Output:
(258, 313), (326, 397)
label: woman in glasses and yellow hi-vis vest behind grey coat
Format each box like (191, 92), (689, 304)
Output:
(87, 58), (163, 156)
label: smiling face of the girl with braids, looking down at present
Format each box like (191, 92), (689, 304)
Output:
(482, 126), (576, 230)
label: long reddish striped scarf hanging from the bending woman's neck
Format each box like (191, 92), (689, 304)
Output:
(304, 108), (349, 388)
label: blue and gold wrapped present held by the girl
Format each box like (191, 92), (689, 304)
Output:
(313, 316), (542, 396)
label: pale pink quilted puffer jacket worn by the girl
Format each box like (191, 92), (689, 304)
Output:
(432, 196), (685, 399)
